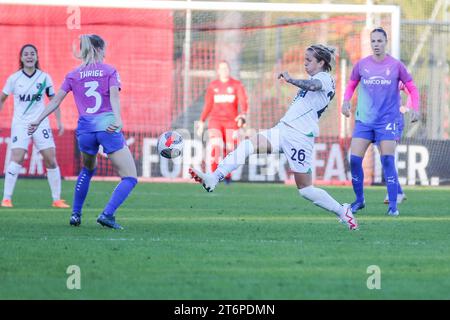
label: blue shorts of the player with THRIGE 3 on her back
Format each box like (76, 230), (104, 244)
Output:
(77, 131), (125, 156)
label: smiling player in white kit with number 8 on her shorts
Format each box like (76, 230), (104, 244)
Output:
(0, 44), (69, 208)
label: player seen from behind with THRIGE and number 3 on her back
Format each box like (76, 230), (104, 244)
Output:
(29, 35), (137, 229)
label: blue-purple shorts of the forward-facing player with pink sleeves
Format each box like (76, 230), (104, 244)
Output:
(352, 121), (403, 144)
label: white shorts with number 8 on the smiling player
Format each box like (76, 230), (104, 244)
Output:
(10, 119), (55, 151)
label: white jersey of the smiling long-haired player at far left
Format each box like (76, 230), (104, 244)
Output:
(3, 69), (55, 124)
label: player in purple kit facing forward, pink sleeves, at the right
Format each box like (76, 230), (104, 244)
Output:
(342, 28), (419, 216)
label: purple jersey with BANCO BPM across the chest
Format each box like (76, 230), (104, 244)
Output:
(350, 55), (412, 124)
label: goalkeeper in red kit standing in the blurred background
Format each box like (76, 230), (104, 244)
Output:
(197, 60), (248, 182)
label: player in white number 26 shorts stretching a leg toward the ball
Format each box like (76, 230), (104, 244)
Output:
(190, 45), (358, 230)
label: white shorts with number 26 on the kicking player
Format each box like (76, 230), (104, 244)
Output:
(259, 122), (314, 173)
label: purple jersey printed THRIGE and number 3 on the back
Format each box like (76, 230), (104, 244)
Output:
(61, 62), (120, 133)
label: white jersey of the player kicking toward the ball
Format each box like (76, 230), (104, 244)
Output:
(280, 72), (336, 137)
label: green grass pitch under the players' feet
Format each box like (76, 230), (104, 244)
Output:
(0, 179), (450, 300)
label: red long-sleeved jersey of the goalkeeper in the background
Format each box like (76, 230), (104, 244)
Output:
(200, 78), (248, 121)
